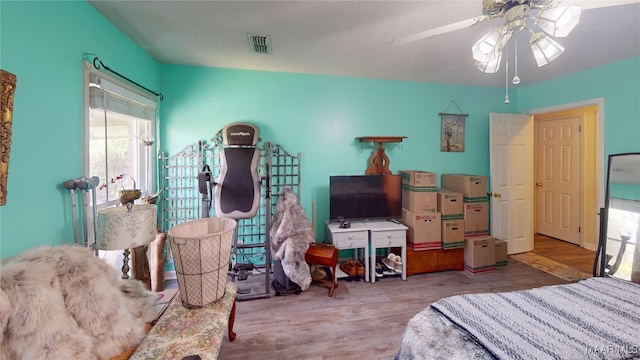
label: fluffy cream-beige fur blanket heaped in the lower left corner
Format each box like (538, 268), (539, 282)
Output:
(0, 245), (156, 360)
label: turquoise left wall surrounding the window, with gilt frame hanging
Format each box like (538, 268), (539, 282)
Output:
(0, 0), (160, 258)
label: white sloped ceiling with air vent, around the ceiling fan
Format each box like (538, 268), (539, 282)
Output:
(89, 0), (640, 86)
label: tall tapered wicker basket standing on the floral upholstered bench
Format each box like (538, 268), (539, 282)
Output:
(167, 218), (237, 309)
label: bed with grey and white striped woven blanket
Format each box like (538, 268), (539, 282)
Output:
(395, 277), (640, 360)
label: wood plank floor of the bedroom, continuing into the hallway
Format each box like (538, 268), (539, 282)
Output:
(219, 239), (593, 360)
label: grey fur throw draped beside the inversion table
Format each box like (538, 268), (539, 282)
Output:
(270, 186), (315, 291)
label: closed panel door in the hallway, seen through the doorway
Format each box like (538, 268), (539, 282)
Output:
(535, 116), (582, 244)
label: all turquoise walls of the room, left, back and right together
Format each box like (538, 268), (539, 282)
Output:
(0, 0), (640, 258)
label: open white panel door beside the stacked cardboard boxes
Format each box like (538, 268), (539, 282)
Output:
(489, 113), (534, 254)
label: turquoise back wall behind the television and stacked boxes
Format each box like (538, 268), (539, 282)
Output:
(161, 65), (517, 239)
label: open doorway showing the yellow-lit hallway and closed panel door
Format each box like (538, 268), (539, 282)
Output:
(534, 105), (602, 250)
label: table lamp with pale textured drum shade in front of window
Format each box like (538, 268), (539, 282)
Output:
(96, 203), (158, 279)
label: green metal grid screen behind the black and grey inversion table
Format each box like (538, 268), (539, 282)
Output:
(160, 132), (301, 300)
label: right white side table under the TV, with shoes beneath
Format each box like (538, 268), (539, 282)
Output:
(364, 221), (408, 284)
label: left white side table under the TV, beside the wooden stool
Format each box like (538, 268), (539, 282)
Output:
(327, 223), (369, 282)
